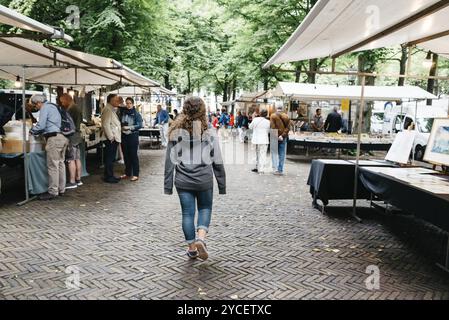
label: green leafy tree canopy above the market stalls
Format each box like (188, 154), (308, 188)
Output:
(0, 0), (449, 100)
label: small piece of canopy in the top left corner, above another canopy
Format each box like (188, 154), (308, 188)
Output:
(0, 5), (73, 42)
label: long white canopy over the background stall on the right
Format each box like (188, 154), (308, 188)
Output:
(273, 82), (438, 101)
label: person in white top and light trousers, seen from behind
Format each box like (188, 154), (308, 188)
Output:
(249, 110), (270, 173)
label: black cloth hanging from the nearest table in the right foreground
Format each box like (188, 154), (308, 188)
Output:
(360, 168), (449, 231)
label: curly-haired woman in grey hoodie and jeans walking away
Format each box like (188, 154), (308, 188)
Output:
(164, 97), (226, 260)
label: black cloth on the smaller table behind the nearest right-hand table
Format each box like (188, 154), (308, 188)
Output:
(307, 160), (392, 206)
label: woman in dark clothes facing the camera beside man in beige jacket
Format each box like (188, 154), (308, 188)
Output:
(120, 98), (143, 182)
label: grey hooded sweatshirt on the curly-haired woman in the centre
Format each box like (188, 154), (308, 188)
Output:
(164, 135), (226, 195)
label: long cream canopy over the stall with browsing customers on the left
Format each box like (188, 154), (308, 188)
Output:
(0, 38), (170, 92)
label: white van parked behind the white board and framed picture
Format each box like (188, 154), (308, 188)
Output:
(383, 102), (448, 161)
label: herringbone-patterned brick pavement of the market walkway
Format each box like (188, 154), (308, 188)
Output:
(0, 140), (449, 299)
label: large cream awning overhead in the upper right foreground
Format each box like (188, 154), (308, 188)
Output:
(264, 0), (449, 68)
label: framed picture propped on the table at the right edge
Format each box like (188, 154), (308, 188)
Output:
(424, 118), (449, 166)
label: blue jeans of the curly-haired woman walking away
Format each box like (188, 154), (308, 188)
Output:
(178, 189), (214, 244)
